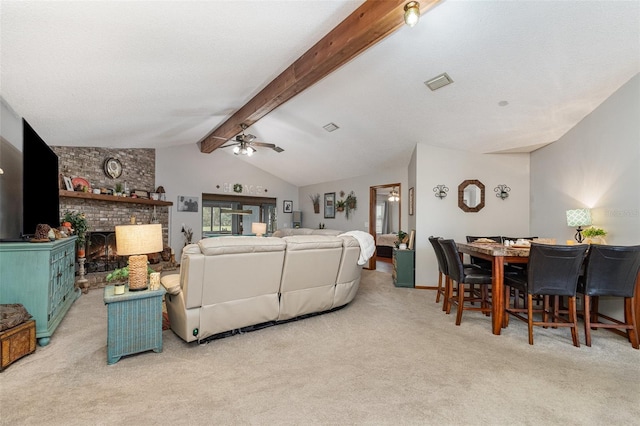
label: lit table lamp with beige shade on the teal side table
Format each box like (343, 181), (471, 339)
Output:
(116, 223), (163, 291)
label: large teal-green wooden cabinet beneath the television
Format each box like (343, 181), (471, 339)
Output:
(0, 237), (80, 346)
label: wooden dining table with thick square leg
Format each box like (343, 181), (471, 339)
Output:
(456, 242), (529, 335)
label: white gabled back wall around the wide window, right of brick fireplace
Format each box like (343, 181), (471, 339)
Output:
(156, 144), (298, 259)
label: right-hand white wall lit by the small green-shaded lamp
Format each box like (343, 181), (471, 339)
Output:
(531, 74), (640, 245)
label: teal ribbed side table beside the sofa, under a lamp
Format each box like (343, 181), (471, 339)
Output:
(104, 285), (165, 364)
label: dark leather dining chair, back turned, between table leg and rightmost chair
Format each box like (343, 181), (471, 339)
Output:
(504, 242), (588, 347)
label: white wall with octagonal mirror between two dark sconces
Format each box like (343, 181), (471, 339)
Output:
(415, 144), (532, 286)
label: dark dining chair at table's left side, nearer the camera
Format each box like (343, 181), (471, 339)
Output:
(438, 238), (492, 325)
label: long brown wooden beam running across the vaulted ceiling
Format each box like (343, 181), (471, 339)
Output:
(200, 0), (440, 153)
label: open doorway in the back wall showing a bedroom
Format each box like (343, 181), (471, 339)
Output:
(366, 183), (402, 271)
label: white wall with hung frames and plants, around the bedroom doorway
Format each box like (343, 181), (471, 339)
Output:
(294, 168), (408, 232)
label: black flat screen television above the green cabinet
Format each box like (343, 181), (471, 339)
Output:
(22, 118), (60, 237)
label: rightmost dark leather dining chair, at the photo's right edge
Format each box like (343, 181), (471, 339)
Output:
(578, 244), (640, 349)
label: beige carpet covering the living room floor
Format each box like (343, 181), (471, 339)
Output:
(0, 271), (640, 425)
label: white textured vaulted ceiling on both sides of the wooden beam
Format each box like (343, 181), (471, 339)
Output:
(0, 0), (640, 186)
